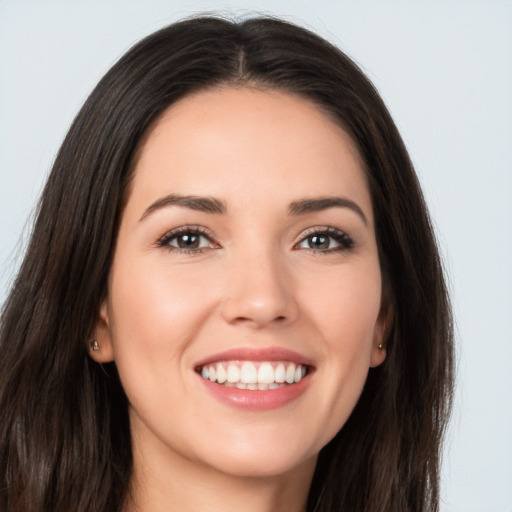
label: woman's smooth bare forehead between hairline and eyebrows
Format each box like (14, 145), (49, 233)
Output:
(126, 87), (371, 220)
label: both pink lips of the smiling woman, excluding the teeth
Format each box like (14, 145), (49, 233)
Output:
(195, 347), (314, 411)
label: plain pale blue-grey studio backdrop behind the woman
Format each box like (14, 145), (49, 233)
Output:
(0, 0), (512, 512)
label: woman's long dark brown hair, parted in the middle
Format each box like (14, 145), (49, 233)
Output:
(0, 17), (453, 512)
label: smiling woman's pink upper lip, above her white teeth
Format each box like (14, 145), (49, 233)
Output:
(195, 347), (313, 367)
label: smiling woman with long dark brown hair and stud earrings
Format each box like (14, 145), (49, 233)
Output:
(0, 17), (453, 512)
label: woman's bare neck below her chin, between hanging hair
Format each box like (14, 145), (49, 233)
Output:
(124, 430), (316, 512)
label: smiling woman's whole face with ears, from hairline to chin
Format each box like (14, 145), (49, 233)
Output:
(93, 87), (385, 476)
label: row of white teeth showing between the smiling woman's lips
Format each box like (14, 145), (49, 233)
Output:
(196, 361), (310, 391)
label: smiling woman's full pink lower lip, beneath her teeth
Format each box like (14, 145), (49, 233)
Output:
(198, 375), (311, 411)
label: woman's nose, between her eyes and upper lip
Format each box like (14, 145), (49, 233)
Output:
(222, 251), (298, 329)
